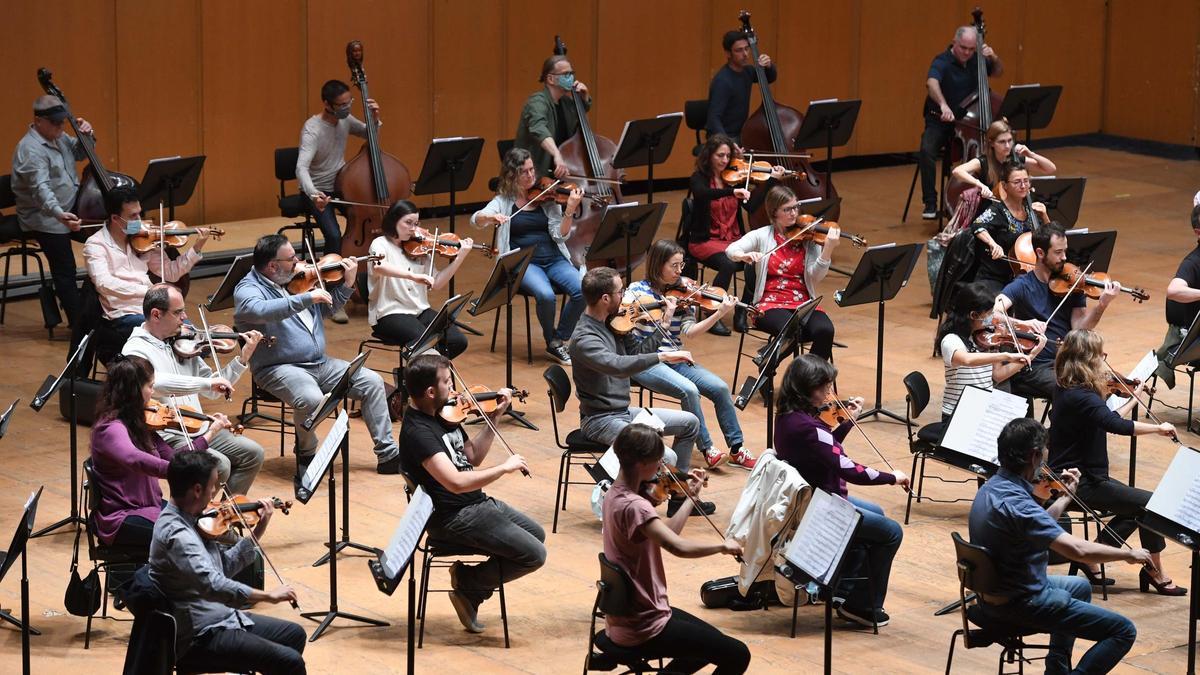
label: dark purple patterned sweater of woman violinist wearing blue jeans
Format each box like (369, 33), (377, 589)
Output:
(775, 411), (896, 498)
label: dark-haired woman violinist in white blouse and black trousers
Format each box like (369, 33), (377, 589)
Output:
(367, 199), (473, 359)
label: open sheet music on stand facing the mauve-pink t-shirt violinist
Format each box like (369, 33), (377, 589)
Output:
(784, 489), (862, 585)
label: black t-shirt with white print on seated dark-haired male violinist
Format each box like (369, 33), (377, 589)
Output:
(400, 406), (487, 511)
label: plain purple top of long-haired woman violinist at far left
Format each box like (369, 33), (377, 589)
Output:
(91, 418), (209, 544)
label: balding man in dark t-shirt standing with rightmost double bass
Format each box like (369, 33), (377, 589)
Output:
(918, 25), (1004, 220)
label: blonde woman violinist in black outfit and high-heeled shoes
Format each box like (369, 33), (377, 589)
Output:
(1048, 330), (1186, 596)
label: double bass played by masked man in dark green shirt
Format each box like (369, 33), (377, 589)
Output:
(554, 35), (628, 268)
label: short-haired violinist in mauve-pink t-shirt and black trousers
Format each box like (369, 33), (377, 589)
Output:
(604, 424), (750, 674)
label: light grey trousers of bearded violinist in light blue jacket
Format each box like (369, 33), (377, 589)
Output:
(254, 358), (400, 461)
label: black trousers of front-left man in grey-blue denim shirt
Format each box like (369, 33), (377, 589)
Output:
(176, 614), (307, 675)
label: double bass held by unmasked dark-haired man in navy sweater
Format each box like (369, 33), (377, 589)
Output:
(738, 10), (841, 227)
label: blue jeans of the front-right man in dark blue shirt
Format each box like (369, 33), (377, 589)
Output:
(980, 577), (1138, 675)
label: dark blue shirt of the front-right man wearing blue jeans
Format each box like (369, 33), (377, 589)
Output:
(970, 468), (1063, 598)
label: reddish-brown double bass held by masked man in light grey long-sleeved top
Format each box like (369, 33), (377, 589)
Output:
(334, 40), (413, 257)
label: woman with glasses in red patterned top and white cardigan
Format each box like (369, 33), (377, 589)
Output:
(725, 185), (841, 360)
